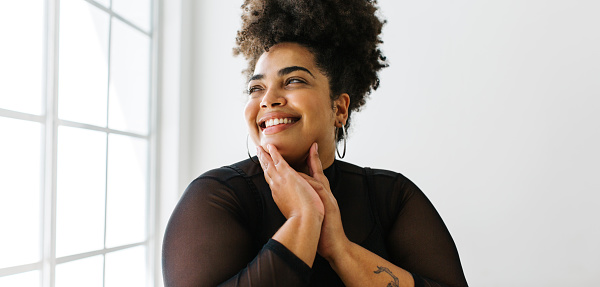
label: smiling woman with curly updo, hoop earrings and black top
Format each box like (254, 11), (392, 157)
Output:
(163, 0), (466, 286)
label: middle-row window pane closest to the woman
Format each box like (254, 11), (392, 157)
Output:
(106, 134), (148, 247)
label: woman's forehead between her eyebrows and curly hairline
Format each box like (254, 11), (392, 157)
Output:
(254, 43), (319, 75)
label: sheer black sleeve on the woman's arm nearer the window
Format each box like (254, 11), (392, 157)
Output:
(162, 170), (310, 286)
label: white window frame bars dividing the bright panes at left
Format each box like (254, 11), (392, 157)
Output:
(0, 0), (165, 287)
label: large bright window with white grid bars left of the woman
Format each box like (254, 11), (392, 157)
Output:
(0, 0), (156, 287)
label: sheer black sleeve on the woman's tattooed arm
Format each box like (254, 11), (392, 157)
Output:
(387, 176), (467, 286)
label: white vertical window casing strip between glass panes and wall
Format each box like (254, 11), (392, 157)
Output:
(154, 0), (194, 286)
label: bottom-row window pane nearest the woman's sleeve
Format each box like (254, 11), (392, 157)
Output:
(105, 246), (146, 287)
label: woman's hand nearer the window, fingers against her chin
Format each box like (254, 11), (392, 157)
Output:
(257, 144), (325, 220)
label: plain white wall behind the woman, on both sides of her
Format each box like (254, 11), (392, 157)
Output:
(184, 0), (600, 286)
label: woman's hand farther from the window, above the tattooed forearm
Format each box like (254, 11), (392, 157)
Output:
(300, 143), (350, 261)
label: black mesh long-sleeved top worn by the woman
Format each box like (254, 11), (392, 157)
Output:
(162, 159), (467, 286)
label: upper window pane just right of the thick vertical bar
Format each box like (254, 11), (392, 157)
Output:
(58, 0), (109, 127)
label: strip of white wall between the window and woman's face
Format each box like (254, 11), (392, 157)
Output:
(191, 1), (248, 175)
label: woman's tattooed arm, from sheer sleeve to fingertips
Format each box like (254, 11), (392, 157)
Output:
(304, 143), (467, 286)
